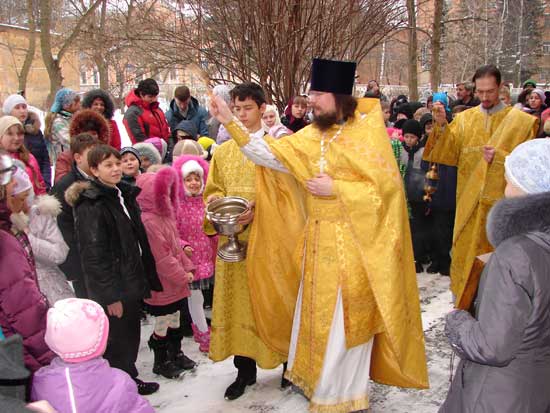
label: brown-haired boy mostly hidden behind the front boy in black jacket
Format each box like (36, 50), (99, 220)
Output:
(51, 133), (99, 298)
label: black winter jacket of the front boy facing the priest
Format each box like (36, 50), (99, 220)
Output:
(65, 180), (162, 306)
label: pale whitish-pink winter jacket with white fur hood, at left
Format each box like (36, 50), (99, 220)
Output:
(12, 195), (74, 305)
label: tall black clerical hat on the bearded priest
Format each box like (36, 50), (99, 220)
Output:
(310, 58), (357, 95)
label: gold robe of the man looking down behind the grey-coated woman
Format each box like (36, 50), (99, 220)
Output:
(424, 106), (537, 304)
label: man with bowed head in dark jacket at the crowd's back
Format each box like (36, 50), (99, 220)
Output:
(166, 86), (209, 139)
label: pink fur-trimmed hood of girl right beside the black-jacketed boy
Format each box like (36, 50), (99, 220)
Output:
(136, 168), (179, 219)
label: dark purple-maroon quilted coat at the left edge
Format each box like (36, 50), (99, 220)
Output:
(0, 203), (54, 372)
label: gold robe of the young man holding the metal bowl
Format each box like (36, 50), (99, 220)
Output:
(204, 141), (286, 369)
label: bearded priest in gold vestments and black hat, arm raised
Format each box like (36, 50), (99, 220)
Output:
(210, 59), (428, 413)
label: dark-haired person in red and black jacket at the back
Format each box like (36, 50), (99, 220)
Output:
(124, 79), (170, 144)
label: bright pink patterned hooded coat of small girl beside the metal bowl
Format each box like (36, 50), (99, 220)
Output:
(173, 155), (218, 281)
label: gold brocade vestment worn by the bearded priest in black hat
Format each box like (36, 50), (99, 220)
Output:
(226, 98), (428, 411)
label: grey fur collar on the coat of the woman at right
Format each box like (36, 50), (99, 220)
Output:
(487, 192), (550, 248)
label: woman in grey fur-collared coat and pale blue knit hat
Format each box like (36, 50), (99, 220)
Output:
(440, 139), (550, 413)
